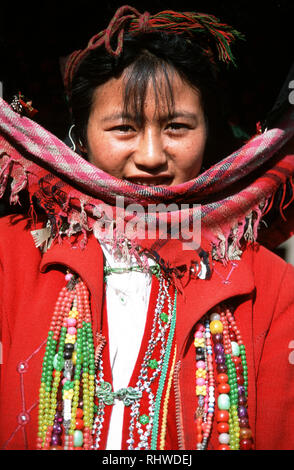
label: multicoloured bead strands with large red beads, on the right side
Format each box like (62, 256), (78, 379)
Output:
(194, 308), (252, 450)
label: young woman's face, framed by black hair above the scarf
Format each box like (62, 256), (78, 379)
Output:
(87, 70), (207, 186)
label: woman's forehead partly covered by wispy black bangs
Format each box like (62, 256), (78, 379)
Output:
(92, 70), (202, 116)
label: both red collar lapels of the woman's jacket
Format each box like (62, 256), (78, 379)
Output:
(40, 235), (255, 353)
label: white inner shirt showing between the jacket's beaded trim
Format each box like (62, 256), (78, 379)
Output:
(101, 243), (155, 450)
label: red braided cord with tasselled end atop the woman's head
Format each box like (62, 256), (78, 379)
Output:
(64, 5), (243, 94)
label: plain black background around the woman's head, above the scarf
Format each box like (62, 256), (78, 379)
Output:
(0, 0), (294, 264)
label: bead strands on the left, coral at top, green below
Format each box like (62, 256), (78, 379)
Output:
(37, 273), (95, 450)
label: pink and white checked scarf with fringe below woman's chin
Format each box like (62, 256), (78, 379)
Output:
(0, 99), (294, 276)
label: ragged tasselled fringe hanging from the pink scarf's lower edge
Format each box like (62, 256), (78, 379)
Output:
(0, 154), (294, 269)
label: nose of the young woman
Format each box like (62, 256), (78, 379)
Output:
(134, 129), (167, 173)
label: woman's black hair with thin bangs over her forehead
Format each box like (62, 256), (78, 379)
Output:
(70, 32), (237, 168)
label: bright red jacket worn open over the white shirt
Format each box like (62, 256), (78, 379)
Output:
(0, 216), (294, 450)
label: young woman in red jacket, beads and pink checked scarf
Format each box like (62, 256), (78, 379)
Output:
(0, 7), (294, 450)
